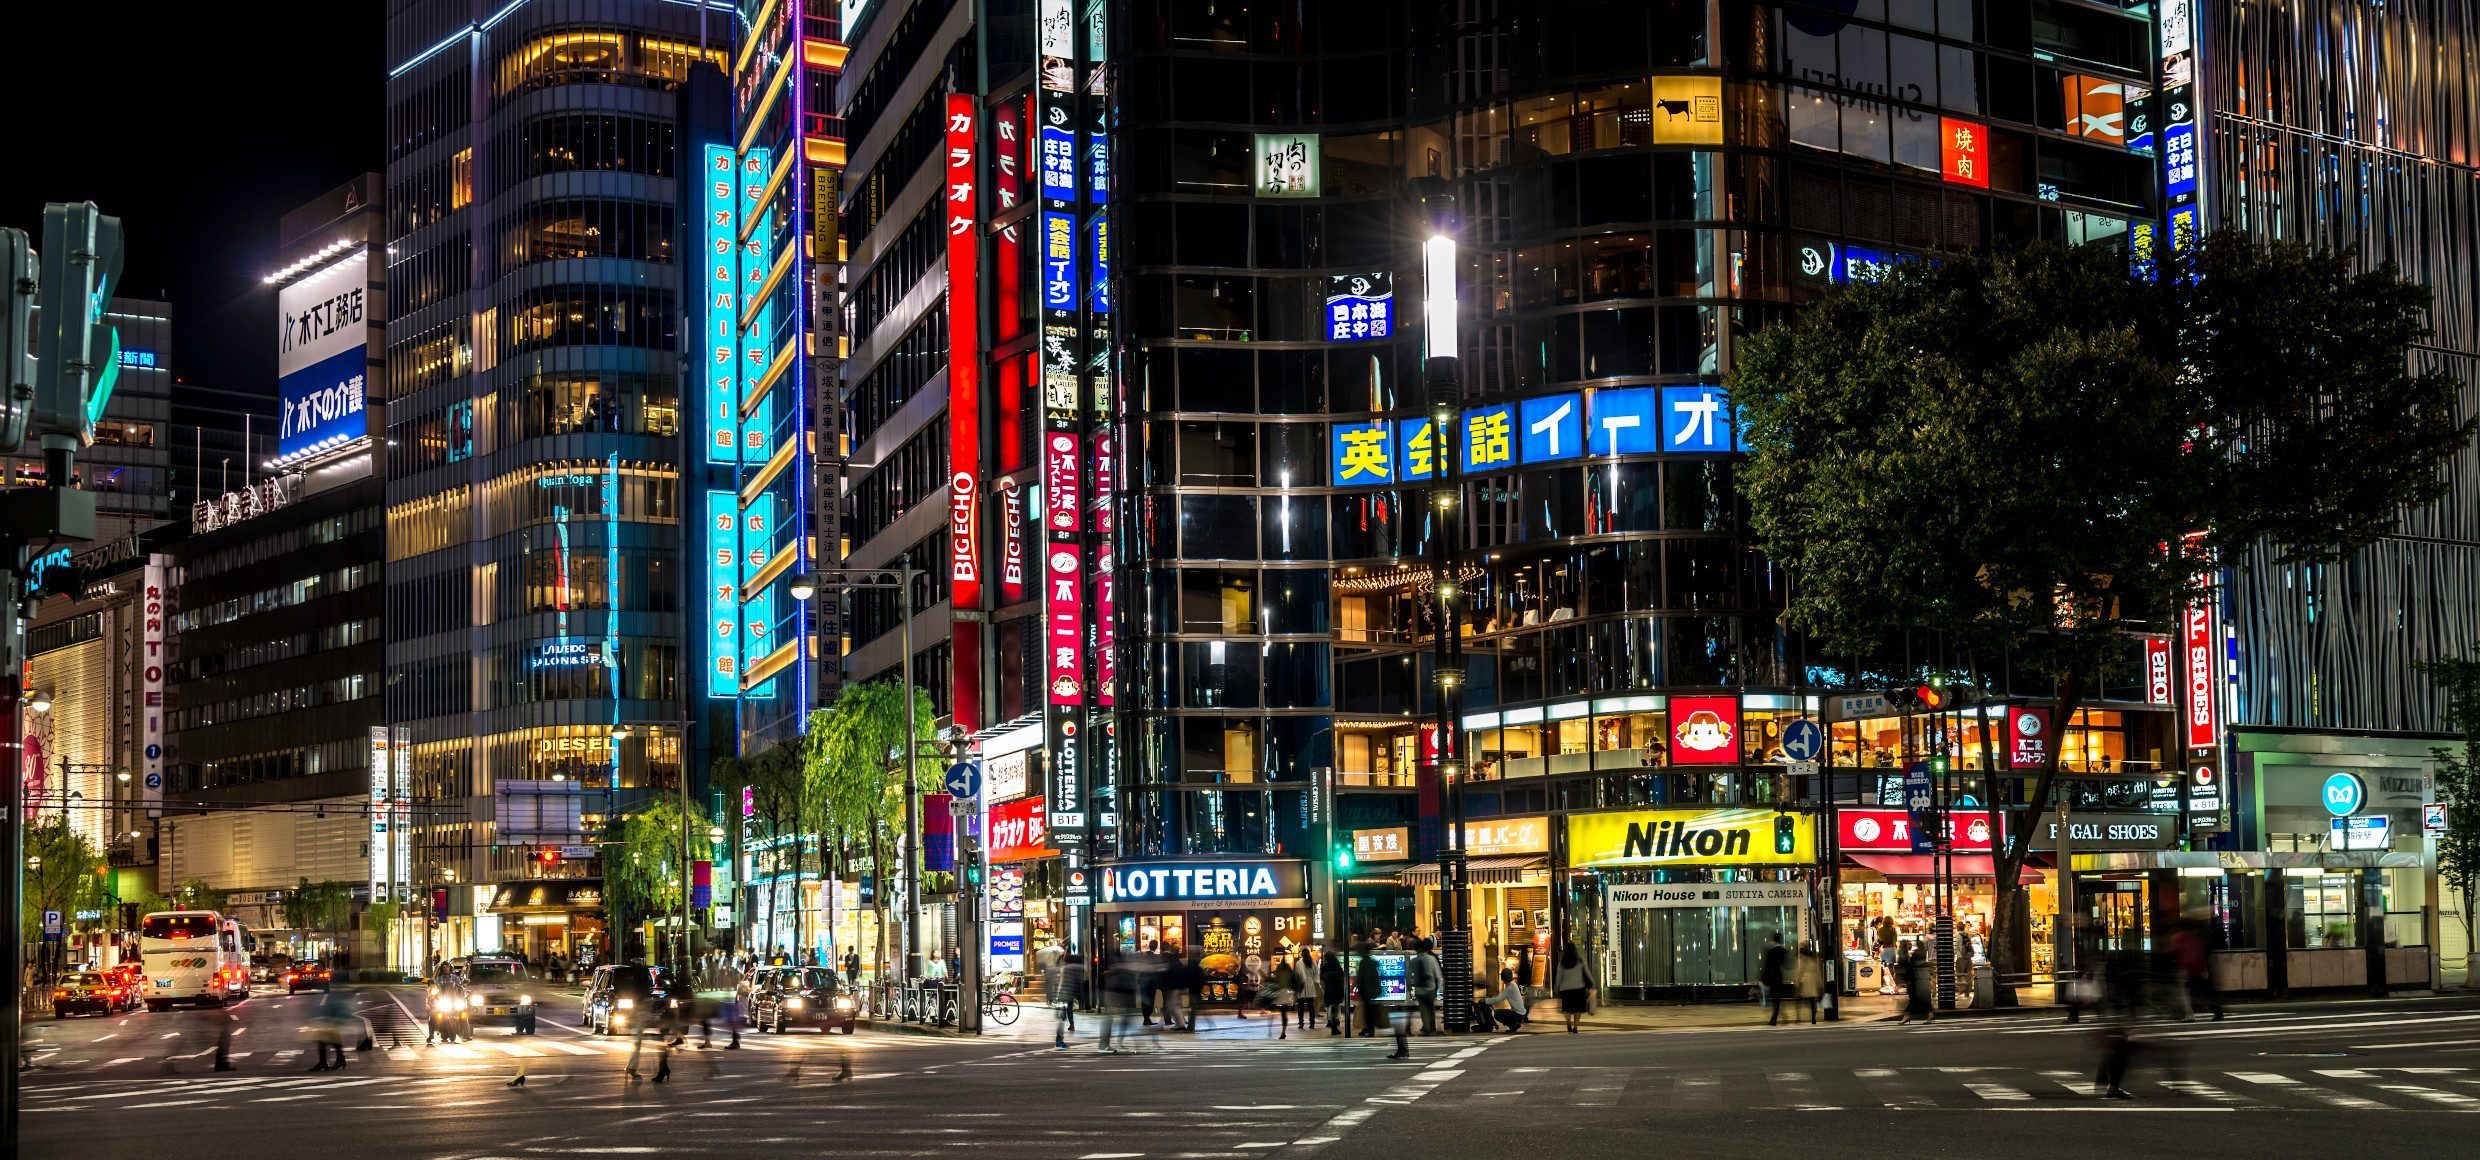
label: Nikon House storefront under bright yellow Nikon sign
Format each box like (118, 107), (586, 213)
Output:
(1565, 808), (1818, 999)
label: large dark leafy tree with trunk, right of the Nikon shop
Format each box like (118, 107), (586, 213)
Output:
(1731, 233), (2473, 999)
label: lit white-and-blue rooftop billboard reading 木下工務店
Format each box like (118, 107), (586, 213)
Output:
(275, 250), (370, 459)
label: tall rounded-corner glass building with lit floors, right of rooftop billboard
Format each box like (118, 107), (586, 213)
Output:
(384, 0), (737, 954)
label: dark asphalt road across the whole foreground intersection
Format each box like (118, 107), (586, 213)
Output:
(22, 989), (2480, 1160)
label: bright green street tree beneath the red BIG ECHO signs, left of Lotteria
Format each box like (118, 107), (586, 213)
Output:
(801, 682), (940, 981)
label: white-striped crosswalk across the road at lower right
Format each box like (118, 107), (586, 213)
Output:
(1463, 1066), (2480, 1115)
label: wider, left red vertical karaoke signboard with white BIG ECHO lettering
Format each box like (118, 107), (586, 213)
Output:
(947, 92), (982, 731)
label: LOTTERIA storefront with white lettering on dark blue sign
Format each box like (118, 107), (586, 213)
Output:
(1094, 858), (1324, 1001)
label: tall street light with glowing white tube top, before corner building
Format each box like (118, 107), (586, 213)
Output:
(1421, 183), (1473, 1034)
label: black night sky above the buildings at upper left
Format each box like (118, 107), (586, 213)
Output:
(0, 0), (387, 397)
